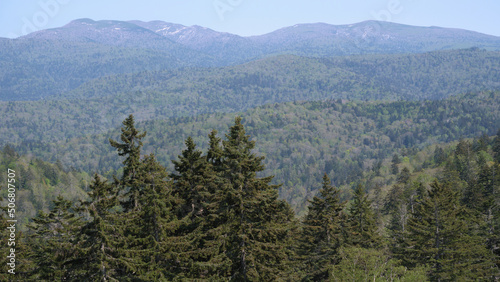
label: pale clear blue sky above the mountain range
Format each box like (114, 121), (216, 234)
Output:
(0, 0), (500, 38)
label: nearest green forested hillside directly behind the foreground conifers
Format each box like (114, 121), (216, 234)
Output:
(16, 92), (500, 212)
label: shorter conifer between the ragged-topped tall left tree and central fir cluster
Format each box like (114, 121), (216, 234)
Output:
(126, 154), (184, 281)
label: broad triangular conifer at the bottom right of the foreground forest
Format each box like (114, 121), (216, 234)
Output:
(400, 182), (493, 281)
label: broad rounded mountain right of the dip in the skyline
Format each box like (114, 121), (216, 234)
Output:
(252, 21), (500, 56)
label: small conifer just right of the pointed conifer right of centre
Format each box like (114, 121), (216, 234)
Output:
(346, 185), (381, 248)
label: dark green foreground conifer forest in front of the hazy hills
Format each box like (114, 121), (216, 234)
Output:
(1, 115), (500, 281)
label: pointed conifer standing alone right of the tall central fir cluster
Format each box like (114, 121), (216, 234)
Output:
(299, 173), (344, 281)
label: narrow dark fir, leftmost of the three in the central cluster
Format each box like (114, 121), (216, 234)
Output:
(170, 135), (221, 279)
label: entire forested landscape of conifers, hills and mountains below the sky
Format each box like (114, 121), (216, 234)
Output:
(0, 19), (500, 281)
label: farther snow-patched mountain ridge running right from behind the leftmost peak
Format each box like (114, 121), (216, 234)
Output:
(134, 21), (500, 63)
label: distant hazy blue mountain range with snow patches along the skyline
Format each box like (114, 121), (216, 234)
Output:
(0, 19), (500, 101)
